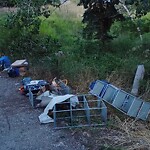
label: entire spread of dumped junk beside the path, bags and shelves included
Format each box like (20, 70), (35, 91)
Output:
(0, 56), (150, 128)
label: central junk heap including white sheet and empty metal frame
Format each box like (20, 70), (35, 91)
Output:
(19, 77), (107, 128)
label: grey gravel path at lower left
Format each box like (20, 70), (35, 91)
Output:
(0, 77), (85, 150)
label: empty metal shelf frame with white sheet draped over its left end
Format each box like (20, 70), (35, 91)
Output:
(36, 91), (107, 129)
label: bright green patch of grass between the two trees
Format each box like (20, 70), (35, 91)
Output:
(40, 12), (82, 51)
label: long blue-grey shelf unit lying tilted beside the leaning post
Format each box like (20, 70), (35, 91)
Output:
(90, 80), (150, 120)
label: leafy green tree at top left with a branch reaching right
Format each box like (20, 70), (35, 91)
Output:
(7, 0), (60, 30)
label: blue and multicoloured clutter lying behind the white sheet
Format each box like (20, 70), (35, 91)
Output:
(20, 77), (71, 96)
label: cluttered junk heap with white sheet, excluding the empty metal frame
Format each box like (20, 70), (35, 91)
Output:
(19, 77), (82, 123)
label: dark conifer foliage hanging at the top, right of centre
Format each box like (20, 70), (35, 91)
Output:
(79, 1), (124, 41)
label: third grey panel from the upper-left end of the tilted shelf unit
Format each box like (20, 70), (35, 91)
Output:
(112, 90), (127, 109)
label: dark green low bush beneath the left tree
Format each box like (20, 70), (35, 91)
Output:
(6, 34), (60, 59)
